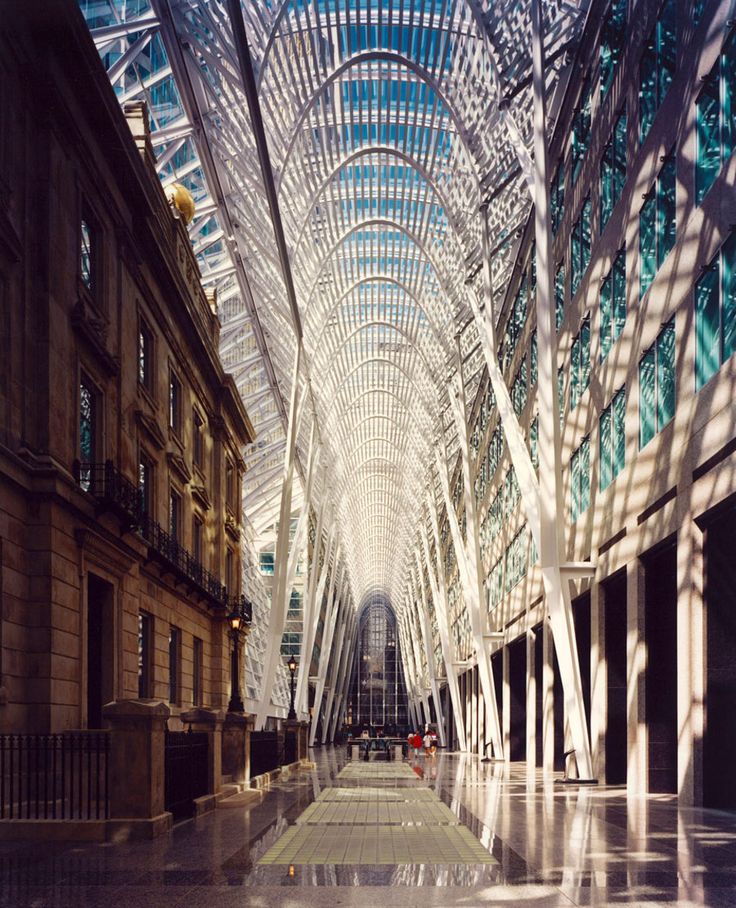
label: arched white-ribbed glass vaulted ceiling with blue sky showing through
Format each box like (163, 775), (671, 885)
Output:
(82, 0), (587, 616)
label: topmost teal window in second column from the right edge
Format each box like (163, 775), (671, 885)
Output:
(639, 0), (677, 142)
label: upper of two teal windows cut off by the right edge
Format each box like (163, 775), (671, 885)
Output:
(695, 34), (736, 204)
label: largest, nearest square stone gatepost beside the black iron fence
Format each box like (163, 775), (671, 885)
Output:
(102, 700), (173, 841)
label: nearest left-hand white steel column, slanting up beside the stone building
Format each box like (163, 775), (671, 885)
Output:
(255, 344), (304, 730)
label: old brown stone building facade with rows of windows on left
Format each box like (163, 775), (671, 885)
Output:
(0, 4), (253, 732)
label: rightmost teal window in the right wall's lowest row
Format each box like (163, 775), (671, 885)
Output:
(695, 233), (736, 390)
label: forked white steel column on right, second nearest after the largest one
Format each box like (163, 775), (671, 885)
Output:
(436, 446), (503, 760)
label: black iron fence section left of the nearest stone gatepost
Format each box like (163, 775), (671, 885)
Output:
(0, 731), (110, 820)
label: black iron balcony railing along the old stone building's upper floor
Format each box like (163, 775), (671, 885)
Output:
(72, 460), (253, 623)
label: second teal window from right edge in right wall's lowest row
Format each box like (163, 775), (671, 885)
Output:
(639, 319), (675, 448)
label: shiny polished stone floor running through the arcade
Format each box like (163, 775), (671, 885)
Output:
(0, 748), (736, 908)
